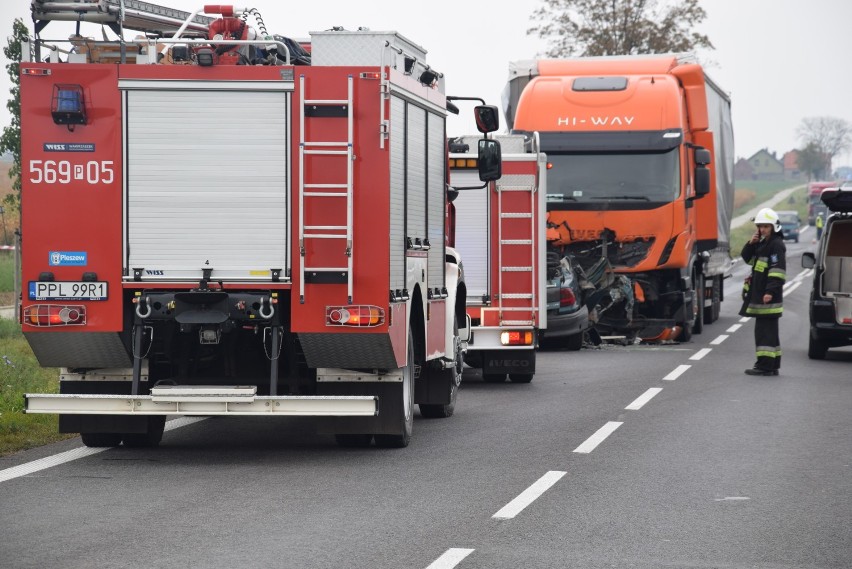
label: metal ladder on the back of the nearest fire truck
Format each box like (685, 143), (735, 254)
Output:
(298, 75), (354, 304)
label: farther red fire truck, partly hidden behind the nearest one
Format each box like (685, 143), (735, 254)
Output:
(450, 135), (547, 383)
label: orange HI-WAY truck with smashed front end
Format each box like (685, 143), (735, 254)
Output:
(503, 55), (734, 341)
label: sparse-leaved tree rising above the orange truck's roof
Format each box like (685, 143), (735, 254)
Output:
(527, 0), (713, 57)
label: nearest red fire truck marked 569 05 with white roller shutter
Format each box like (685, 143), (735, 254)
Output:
(20, 0), (500, 447)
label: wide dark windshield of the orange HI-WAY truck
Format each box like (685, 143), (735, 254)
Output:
(545, 147), (680, 203)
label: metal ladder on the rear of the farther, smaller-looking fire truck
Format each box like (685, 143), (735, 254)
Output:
(495, 182), (538, 326)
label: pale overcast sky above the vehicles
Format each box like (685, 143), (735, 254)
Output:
(0, 0), (852, 167)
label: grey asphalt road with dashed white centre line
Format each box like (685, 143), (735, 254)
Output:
(0, 223), (852, 569)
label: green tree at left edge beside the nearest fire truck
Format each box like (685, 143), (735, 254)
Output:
(0, 18), (30, 212)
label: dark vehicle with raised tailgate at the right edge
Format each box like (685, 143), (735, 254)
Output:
(802, 188), (852, 360)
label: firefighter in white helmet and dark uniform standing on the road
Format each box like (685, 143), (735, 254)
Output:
(740, 207), (787, 375)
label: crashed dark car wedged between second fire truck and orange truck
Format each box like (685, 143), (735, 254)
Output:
(543, 252), (589, 350)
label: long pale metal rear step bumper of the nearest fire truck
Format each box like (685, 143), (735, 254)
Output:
(25, 386), (379, 417)
